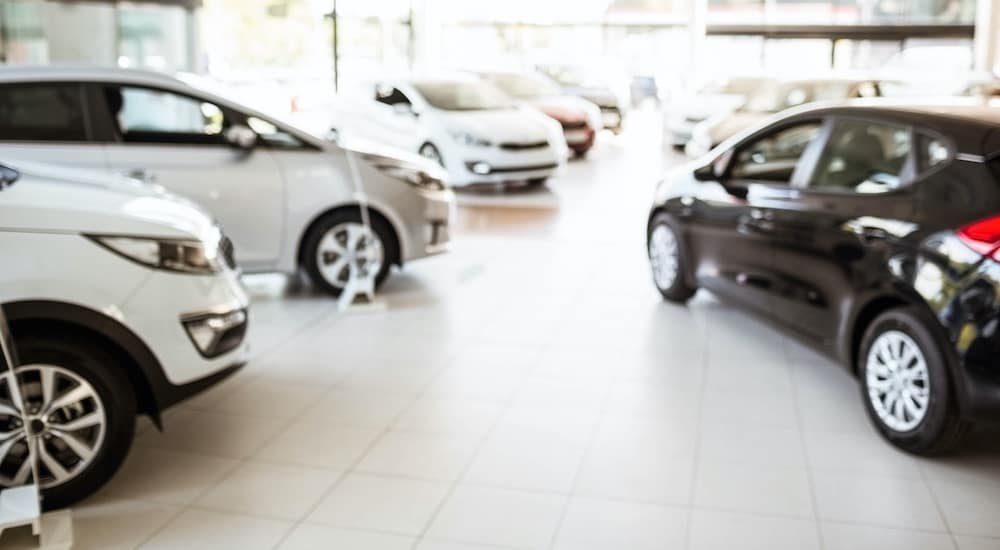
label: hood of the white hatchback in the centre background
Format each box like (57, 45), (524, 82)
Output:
(442, 109), (549, 143)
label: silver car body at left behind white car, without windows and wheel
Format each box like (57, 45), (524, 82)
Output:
(0, 67), (455, 288)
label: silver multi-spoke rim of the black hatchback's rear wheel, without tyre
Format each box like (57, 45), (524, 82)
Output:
(865, 330), (931, 432)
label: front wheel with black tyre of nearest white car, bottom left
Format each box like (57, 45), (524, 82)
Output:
(3, 332), (136, 510)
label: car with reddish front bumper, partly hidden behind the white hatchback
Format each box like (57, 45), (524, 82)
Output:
(480, 72), (604, 157)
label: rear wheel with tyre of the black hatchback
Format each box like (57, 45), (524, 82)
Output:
(858, 307), (972, 456)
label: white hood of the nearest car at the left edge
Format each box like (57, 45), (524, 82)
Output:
(0, 157), (217, 239)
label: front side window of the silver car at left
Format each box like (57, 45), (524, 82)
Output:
(105, 86), (225, 143)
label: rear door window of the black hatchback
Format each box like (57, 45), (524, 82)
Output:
(809, 120), (912, 193)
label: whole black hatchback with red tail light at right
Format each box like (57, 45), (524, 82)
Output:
(647, 101), (1000, 454)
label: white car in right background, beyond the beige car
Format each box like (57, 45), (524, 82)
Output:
(664, 77), (768, 148)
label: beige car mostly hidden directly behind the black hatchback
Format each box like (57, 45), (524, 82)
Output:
(685, 78), (882, 157)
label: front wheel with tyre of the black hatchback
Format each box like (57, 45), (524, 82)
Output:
(646, 212), (698, 304)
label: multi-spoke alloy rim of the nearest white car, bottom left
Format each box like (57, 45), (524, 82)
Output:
(0, 365), (108, 489)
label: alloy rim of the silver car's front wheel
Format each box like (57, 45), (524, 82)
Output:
(316, 222), (385, 288)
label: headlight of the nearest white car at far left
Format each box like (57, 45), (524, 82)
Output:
(88, 235), (223, 275)
